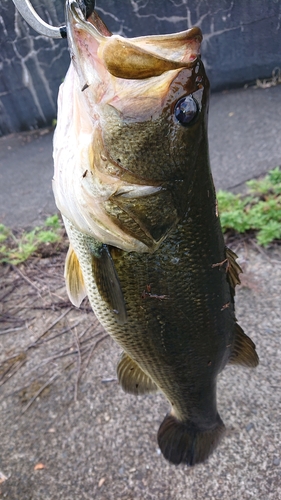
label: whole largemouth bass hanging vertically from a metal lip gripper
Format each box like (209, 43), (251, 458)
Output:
(53, 0), (259, 466)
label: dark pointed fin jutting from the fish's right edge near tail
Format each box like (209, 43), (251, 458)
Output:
(228, 323), (259, 368)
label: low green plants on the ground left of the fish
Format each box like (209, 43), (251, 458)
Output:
(0, 215), (63, 265)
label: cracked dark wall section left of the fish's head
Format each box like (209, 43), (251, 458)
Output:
(0, 0), (69, 135)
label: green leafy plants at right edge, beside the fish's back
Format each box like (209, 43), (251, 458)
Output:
(218, 167), (281, 246)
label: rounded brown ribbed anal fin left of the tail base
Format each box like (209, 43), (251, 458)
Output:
(117, 352), (158, 396)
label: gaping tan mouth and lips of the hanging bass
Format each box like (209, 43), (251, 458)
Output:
(66, 0), (202, 79)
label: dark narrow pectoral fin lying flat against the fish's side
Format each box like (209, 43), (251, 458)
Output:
(92, 245), (127, 325)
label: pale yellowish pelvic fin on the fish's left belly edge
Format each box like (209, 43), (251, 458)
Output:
(64, 245), (87, 307)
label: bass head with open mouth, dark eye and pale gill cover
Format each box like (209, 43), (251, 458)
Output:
(53, 0), (209, 252)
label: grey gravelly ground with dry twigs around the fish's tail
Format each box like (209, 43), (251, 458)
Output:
(0, 242), (281, 500)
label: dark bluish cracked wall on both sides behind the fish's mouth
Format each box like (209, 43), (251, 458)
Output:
(0, 0), (281, 135)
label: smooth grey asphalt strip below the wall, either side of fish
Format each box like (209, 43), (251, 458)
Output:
(0, 85), (281, 228)
